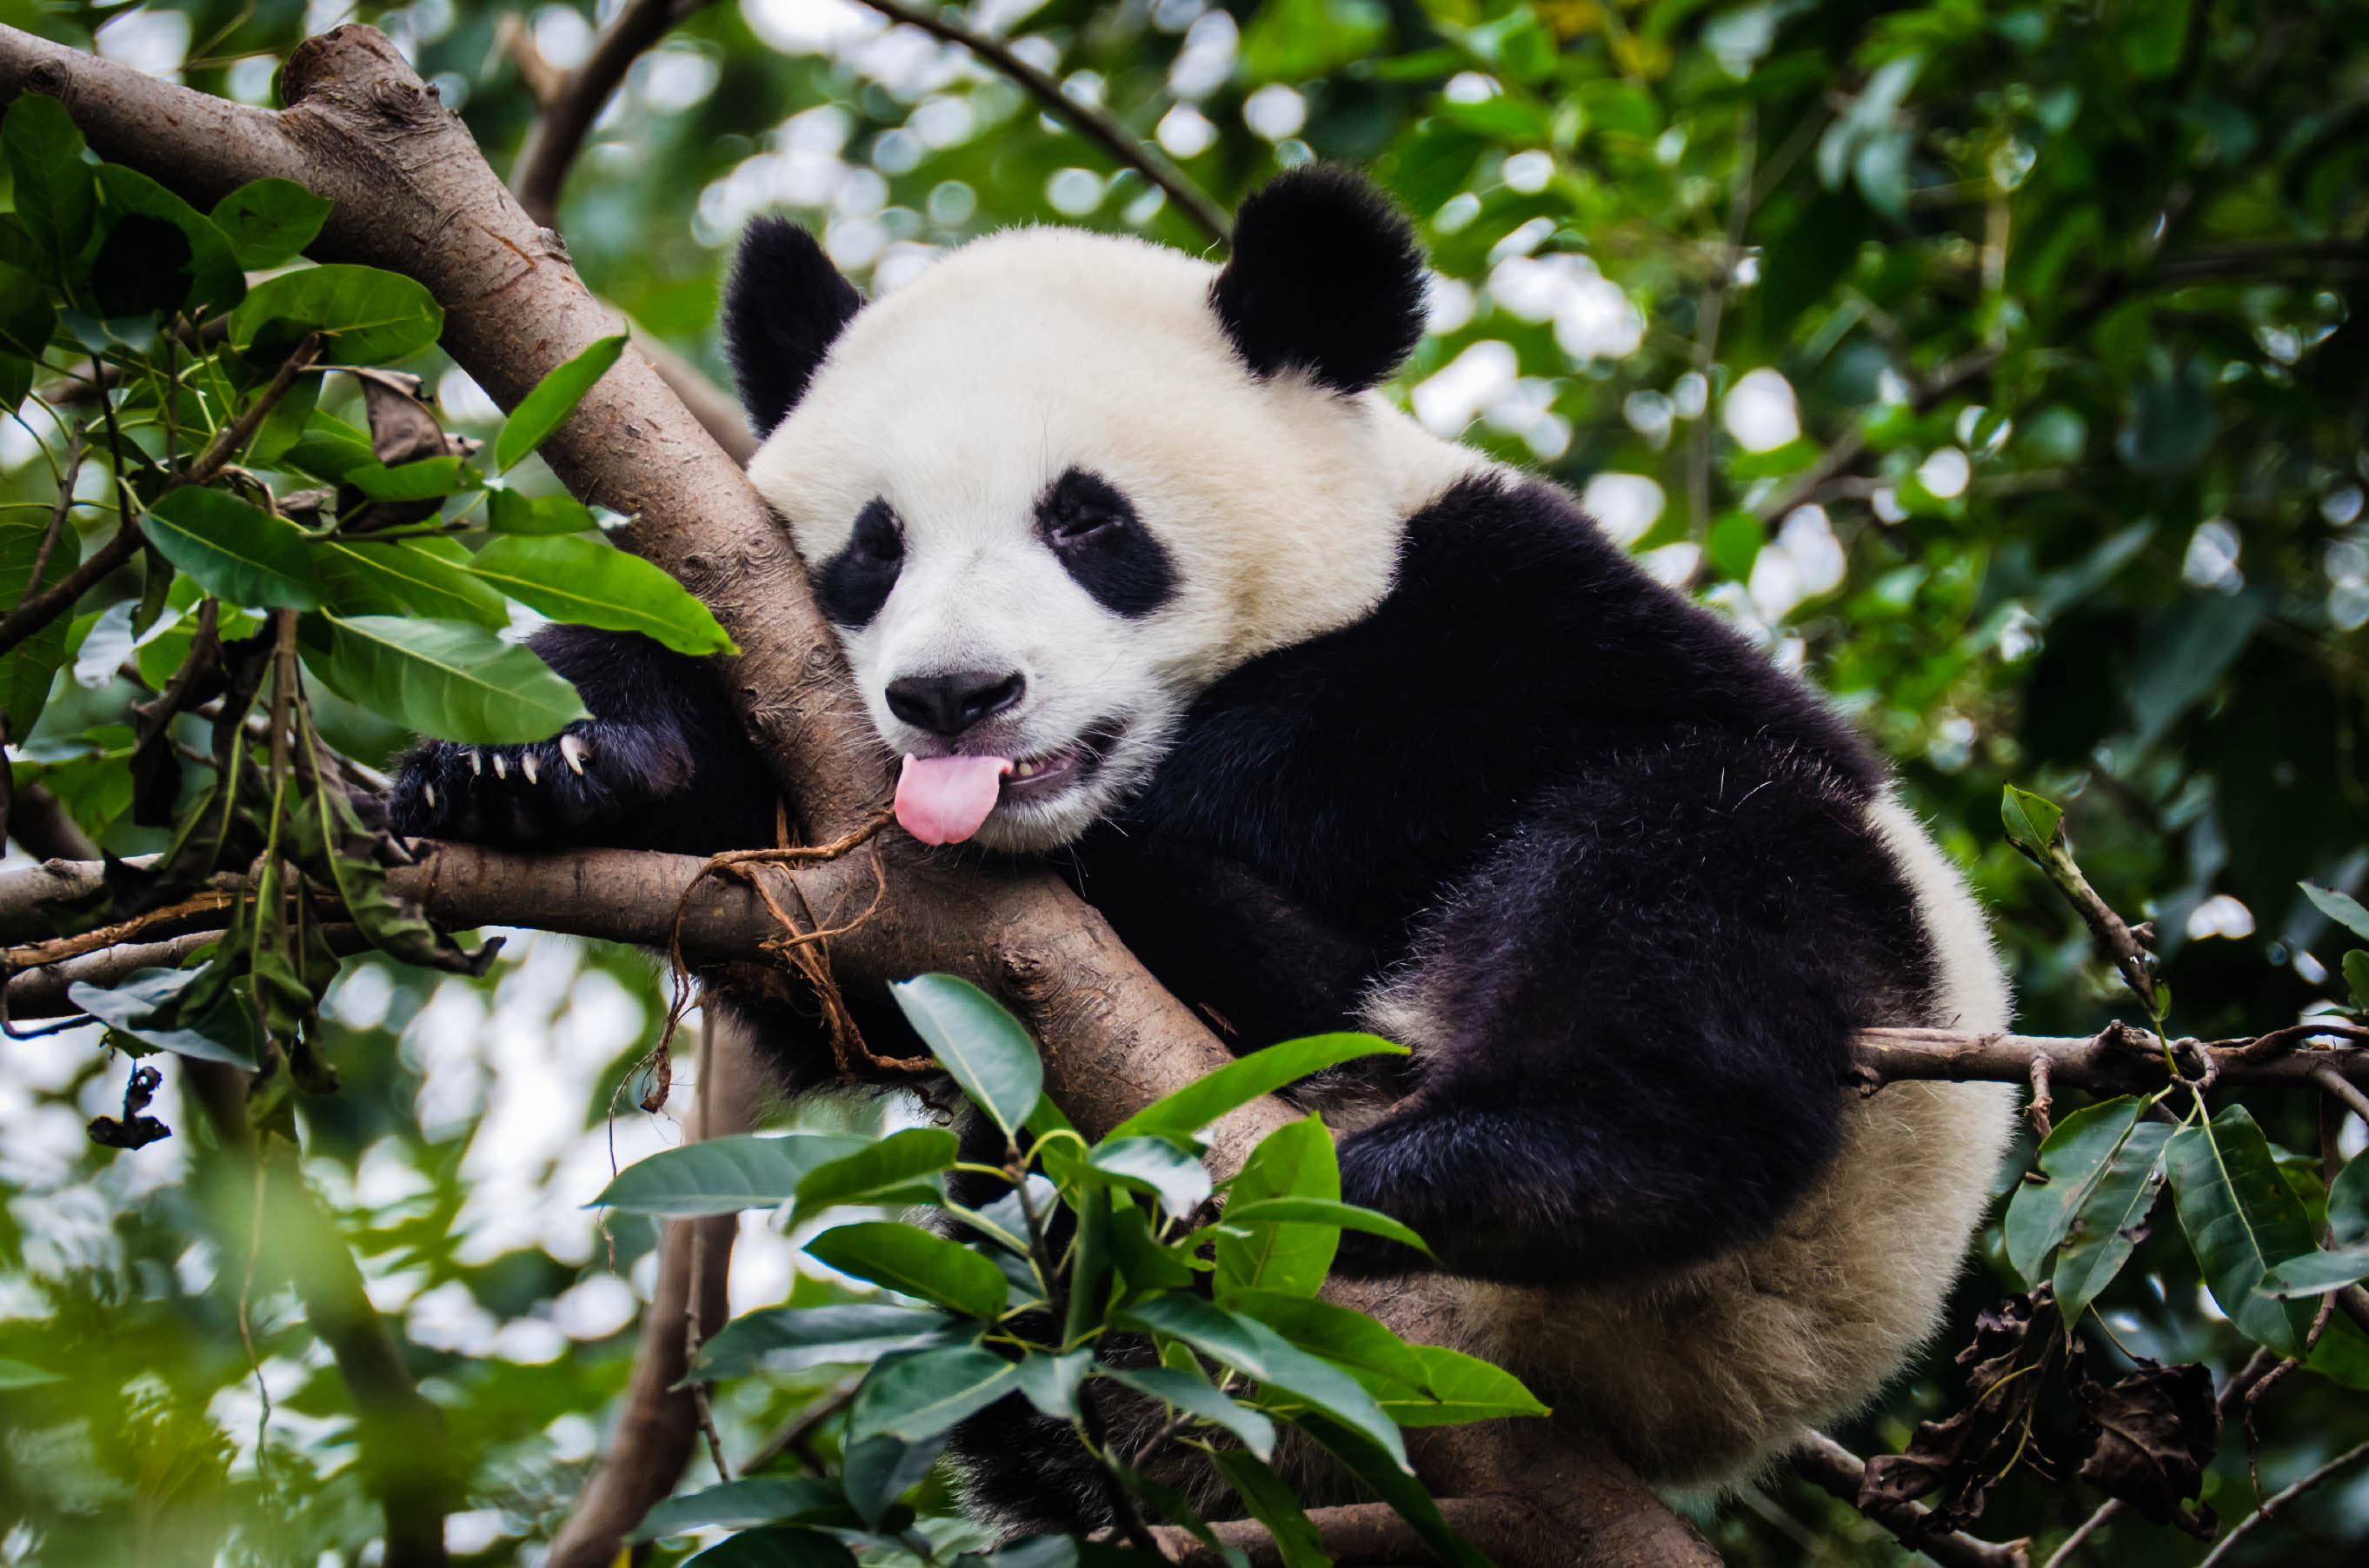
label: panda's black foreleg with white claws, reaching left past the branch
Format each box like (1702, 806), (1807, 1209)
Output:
(389, 625), (775, 855)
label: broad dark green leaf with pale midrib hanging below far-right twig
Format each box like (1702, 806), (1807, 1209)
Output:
(2163, 1106), (2312, 1357)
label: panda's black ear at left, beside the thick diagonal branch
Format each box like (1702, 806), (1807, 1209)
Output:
(725, 218), (865, 435)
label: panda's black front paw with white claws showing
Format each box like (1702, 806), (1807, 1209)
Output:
(386, 720), (692, 848)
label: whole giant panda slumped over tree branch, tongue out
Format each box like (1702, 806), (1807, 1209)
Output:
(393, 166), (2012, 1528)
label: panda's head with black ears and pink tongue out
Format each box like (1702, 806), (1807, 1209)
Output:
(725, 168), (1424, 850)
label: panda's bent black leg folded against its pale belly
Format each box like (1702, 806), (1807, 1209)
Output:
(1336, 748), (1926, 1284)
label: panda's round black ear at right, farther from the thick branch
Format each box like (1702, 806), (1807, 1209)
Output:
(1210, 163), (1424, 393)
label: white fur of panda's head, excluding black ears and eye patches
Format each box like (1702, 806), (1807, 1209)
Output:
(749, 229), (1483, 850)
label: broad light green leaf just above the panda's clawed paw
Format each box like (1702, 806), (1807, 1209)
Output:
(306, 616), (592, 746)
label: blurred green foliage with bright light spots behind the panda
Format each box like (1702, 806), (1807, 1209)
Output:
(0, 0), (2369, 1568)
